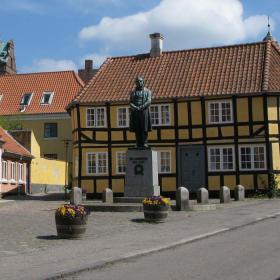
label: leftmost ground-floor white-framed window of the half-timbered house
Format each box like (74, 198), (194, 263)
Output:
(87, 152), (107, 174)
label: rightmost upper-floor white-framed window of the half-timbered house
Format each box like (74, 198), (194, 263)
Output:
(208, 100), (233, 123)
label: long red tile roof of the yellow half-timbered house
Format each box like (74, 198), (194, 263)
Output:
(72, 41), (280, 104)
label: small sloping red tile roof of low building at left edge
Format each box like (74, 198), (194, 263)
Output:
(0, 127), (32, 158)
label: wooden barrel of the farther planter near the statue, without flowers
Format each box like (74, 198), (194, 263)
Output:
(143, 204), (170, 222)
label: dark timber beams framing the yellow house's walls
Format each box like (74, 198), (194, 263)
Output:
(72, 92), (280, 193)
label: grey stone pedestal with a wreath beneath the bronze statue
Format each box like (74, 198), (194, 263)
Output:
(124, 149), (160, 197)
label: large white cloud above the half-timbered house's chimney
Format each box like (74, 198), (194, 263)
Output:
(79, 0), (272, 52)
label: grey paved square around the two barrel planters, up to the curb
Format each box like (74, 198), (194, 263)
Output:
(0, 196), (280, 280)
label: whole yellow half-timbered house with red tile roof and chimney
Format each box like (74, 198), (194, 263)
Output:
(68, 33), (280, 195)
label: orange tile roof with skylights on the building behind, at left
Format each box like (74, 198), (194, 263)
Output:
(0, 71), (84, 115)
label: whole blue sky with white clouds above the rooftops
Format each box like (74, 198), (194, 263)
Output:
(0, 0), (280, 73)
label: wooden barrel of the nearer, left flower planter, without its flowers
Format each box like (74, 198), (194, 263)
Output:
(55, 214), (87, 238)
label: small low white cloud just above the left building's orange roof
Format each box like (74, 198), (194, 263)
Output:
(20, 58), (77, 73)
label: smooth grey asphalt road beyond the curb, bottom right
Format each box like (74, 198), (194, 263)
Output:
(65, 217), (280, 280)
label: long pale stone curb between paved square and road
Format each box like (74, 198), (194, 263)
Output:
(41, 212), (280, 280)
